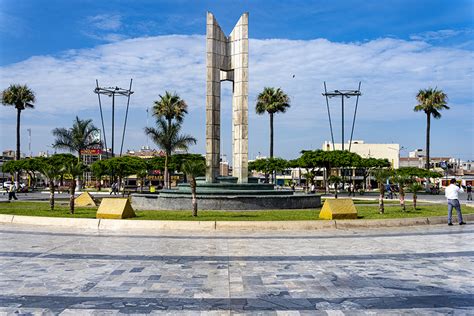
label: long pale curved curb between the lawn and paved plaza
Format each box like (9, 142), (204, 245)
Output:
(0, 214), (474, 231)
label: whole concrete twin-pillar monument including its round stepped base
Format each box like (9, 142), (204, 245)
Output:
(132, 12), (321, 210)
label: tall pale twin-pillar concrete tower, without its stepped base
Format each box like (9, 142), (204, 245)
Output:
(206, 12), (249, 183)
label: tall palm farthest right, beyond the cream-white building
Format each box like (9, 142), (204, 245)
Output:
(413, 88), (449, 170)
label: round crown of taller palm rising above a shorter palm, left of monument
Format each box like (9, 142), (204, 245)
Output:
(153, 91), (188, 126)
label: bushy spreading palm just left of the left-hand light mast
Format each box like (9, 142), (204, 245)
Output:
(52, 116), (101, 161)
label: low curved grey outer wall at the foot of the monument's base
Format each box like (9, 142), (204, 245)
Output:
(132, 194), (321, 210)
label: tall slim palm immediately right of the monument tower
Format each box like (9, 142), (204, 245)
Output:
(255, 87), (290, 158)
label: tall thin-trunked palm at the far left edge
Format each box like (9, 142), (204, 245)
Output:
(2, 84), (36, 165)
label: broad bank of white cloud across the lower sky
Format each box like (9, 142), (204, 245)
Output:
(0, 34), (473, 156)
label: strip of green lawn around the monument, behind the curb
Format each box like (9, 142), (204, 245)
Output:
(0, 202), (474, 221)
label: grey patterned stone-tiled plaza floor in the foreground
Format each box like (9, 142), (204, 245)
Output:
(0, 225), (474, 315)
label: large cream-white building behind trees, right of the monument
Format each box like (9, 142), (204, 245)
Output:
(322, 140), (400, 169)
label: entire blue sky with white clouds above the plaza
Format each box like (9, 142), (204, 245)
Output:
(0, 0), (474, 160)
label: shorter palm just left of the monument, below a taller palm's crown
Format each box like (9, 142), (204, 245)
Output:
(145, 117), (196, 189)
